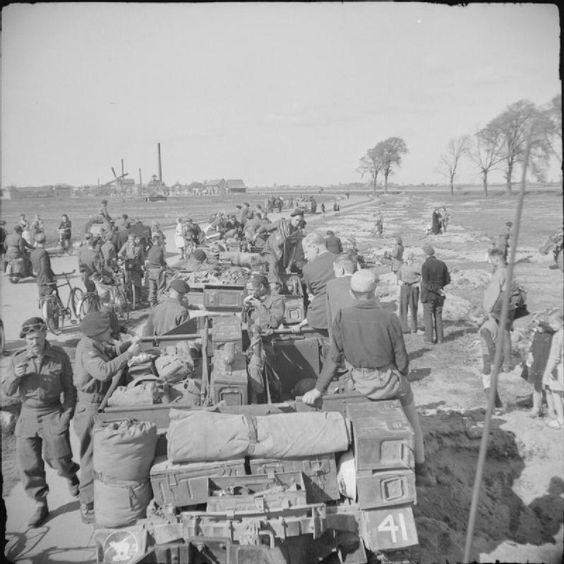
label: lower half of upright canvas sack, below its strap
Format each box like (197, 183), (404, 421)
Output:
(94, 479), (153, 527)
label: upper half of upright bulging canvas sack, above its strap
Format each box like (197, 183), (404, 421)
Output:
(93, 420), (157, 481)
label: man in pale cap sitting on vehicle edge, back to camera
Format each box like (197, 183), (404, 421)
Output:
(302, 270), (435, 486)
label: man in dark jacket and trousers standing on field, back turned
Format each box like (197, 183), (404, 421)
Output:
(421, 244), (450, 344)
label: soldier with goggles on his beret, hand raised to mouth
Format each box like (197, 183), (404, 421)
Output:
(2, 317), (79, 527)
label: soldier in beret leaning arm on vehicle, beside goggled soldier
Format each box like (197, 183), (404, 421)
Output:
(74, 311), (140, 523)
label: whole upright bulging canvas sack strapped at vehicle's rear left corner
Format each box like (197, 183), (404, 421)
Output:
(93, 421), (157, 527)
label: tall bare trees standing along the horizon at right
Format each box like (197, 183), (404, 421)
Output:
(357, 94), (562, 197)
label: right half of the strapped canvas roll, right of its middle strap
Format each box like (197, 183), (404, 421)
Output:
(251, 411), (350, 458)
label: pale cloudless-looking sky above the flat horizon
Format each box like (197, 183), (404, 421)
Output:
(1, 2), (561, 186)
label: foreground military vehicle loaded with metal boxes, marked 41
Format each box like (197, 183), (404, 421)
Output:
(94, 312), (418, 564)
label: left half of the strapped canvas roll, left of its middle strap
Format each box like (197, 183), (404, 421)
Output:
(166, 409), (249, 462)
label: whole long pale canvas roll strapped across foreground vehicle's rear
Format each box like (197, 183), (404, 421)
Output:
(167, 410), (351, 462)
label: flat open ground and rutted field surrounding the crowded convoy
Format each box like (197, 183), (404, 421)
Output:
(1, 189), (564, 563)
